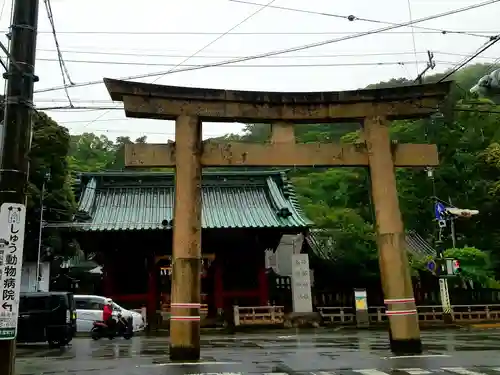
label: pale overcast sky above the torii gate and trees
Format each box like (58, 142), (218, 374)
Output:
(0, 0), (500, 142)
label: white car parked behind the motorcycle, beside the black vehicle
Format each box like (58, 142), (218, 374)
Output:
(75, 295), (145, 332)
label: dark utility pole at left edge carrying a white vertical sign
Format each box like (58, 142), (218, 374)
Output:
(0, 0), (39, 375)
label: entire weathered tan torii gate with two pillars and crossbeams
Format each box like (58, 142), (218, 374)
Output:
(104, 78), (450, 360)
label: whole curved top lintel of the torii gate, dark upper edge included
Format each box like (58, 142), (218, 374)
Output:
(104, 78), (451, 123)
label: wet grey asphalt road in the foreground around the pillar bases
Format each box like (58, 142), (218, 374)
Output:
(11, 329), (500, 375)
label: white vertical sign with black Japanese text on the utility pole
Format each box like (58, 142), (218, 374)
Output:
(0, 203), (26, 340)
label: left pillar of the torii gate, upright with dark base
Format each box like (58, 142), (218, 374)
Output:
(170, 116), (202, 361)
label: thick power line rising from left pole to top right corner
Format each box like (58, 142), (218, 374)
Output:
(35, 0), (500, 93)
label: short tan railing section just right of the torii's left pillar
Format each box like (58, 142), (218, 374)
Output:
(233, 306), (285, 326)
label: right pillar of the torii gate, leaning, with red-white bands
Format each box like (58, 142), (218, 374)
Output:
(363, 116), (422, 355)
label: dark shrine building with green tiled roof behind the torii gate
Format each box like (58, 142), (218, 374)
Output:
(67, 170), (312, 316)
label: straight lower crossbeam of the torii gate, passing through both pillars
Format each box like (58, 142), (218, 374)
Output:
(125, 142), (439, 168)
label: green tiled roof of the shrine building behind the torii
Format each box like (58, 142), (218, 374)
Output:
(69, 171), (312, 231)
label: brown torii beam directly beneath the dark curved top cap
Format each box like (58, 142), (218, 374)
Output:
(123, 96), (440, 123)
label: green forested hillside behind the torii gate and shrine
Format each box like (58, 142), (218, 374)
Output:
(31, 64), (500, 288)
